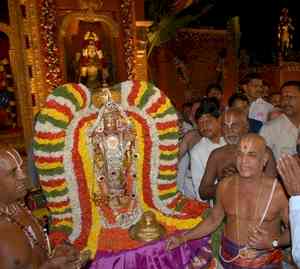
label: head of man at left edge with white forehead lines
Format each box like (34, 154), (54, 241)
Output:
(0, 150), (27, 204)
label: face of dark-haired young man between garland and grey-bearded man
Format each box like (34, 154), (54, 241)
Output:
(197, 114), (220, 140)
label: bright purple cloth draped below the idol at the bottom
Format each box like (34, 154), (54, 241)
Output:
(90, 233), (212, 269)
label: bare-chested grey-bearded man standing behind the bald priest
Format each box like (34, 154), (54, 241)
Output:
(199, 108), (276, 200)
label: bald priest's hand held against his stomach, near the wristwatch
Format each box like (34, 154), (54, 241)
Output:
(247, 227), (273, 250)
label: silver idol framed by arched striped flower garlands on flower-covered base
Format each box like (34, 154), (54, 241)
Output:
(34, 81), (216, 268)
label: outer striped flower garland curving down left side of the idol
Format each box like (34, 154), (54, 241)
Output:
(33, 84), (90, 247)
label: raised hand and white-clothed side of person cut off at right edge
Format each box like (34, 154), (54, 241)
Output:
(277, 152), (300, 268)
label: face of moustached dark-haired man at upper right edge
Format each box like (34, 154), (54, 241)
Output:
(281, 86), (300, 117)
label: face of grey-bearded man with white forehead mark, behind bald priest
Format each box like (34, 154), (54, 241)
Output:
(222, 111), (248, 145)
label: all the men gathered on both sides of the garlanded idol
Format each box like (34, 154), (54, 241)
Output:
(0, 74), (300, 269)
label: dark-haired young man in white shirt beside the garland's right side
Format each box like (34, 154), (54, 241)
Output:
(189, 98), (226, 200)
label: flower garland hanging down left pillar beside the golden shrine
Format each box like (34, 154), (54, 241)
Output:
(40, 0), (62, 89)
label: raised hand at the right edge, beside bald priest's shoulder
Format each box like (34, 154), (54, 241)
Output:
(277, 154), (300, 196)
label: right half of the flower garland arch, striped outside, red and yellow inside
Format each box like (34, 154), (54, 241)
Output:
(119, 81), (207, 226)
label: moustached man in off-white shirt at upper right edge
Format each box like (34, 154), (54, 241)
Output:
(260, 81), (300, 160)
